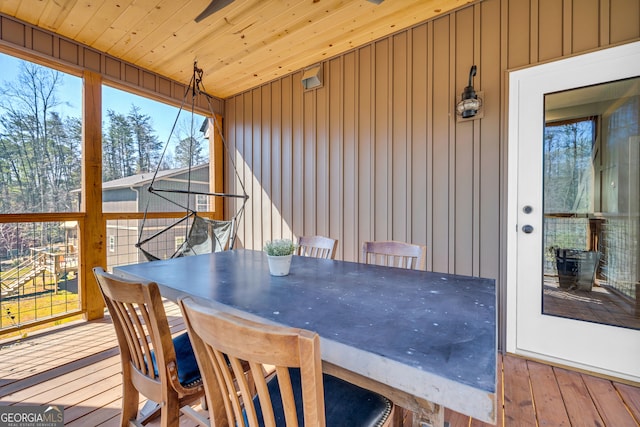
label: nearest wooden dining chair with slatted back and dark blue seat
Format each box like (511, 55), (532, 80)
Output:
(178, 298), (394, 427)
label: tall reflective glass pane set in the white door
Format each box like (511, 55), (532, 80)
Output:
(543, 77), (640, 329)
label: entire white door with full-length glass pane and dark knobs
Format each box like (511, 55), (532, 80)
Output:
(507, 43), (640, 381)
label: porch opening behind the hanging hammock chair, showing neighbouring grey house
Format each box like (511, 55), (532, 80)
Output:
(102, 85), (209, 267)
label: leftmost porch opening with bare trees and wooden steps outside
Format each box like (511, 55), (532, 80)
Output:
(0, 53), (82, 337)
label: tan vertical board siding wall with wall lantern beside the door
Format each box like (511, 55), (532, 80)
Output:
(225, 0), (640, 346)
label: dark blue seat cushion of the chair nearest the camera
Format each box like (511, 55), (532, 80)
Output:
(253, 369), (391, 427)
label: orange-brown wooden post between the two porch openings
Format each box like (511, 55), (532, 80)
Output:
(78, 71), (107, 320)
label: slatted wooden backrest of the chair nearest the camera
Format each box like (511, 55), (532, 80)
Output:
(179, 299), (326, 427)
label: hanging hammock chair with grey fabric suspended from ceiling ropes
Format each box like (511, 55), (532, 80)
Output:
(135, 62), (249, 261)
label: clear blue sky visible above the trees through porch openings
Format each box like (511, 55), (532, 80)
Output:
(0, 53), (208, 160)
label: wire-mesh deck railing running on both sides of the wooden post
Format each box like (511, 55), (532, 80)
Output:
(0, 213), (198, 338)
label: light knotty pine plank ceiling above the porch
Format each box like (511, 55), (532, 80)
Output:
(0, 0), (472, 98)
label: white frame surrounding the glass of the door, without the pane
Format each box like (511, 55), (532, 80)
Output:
(506, 42), (640, 382)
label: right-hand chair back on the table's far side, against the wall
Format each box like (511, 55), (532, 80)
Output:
(362, 240), (427, 270)
